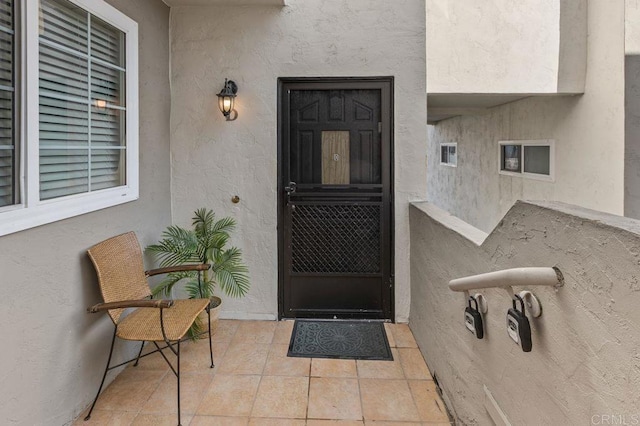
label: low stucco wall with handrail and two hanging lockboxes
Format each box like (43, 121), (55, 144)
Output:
(409, 202), (640, 425)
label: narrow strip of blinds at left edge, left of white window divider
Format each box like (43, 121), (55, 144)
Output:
(0, 0), (17, 207)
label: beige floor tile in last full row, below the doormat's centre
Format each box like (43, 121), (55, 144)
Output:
(307, 377), (362, 420)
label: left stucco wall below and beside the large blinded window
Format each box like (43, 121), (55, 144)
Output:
(0, 0), (171, 425)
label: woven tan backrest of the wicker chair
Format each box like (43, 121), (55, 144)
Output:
(87, 232), (151, 324)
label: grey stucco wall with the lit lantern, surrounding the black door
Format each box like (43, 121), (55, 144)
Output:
(171, 0), (426, 321)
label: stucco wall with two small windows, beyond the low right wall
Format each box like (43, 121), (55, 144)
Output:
(427, 0), (625, 231)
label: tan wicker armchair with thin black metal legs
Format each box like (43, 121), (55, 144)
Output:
(85, 232), (214, 425)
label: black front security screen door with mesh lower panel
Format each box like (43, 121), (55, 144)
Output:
(278, 78), (393, 319)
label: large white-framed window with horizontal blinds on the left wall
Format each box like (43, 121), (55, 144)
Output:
(0, 0), (139, 236)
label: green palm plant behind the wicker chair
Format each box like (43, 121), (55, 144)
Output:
(146, 208), (250, 338)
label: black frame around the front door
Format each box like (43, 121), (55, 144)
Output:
(277, 76), (395, 322)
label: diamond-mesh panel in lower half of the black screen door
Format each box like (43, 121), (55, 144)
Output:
(291, 204), (381, 273)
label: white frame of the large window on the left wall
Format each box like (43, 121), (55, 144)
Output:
(0, 0), (139, 236)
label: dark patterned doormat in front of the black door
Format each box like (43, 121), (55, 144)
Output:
(287, 320), (393, 361)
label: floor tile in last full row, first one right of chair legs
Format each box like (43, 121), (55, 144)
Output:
(196, 374), (260, 417)
